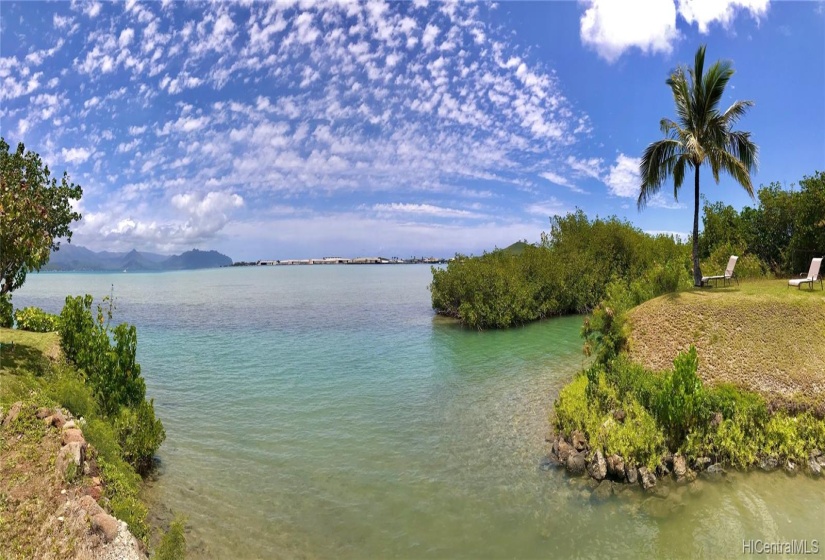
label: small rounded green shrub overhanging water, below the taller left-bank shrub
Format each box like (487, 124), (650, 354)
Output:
(115, 401), (166, 473)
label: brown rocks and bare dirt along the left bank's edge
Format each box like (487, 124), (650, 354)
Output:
(0, 402), (147, 560)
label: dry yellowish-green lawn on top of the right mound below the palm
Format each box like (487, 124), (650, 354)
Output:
(629, 280), (825, 406)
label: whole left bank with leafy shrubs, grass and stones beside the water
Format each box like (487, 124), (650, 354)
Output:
(0, 295), (186, 558)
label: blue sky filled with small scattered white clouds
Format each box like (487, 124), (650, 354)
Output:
(0, 0), (825, 260)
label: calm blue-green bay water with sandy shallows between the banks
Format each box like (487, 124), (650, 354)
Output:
(14, 265), (825, 559)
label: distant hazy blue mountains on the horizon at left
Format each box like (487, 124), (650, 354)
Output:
(43, 243), (232, 272)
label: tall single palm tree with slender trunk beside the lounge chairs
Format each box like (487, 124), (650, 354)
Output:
(638, 45), (758, 286)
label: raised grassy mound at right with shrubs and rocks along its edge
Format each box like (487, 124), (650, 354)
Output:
(551, 280), (825, 487)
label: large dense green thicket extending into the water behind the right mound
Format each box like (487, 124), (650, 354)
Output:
(430, 211), (690, 329)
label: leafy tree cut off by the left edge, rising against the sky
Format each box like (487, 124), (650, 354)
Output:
(0, 137), (83, 295)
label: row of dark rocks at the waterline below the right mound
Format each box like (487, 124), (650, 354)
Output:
(542, 431), (825, 499)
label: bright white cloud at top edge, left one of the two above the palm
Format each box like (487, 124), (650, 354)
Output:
(580, 0), (678, 62)
